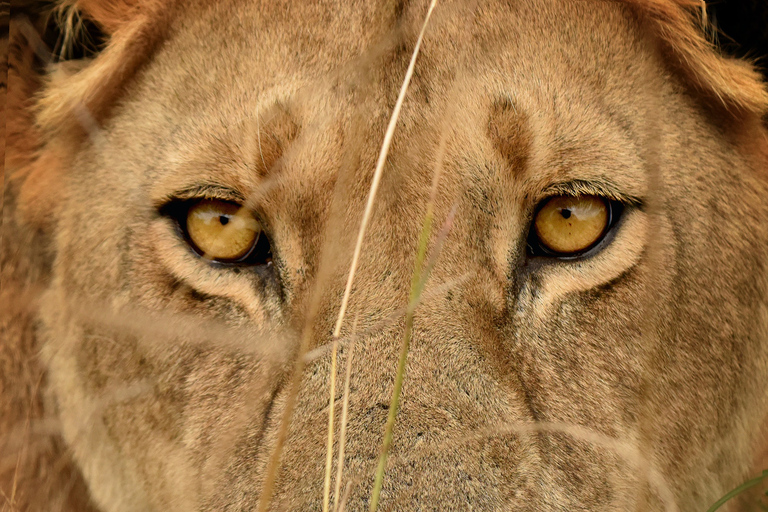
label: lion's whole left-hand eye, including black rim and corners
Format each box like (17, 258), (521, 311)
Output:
(160, 198), (272, 267)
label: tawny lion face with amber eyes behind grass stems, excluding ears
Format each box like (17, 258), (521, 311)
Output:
(27, 0), (768, 511)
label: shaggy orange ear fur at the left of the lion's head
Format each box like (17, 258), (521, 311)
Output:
(5, 0), (173, 228)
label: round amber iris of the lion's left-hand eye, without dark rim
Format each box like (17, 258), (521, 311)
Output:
(186, 199), (261, 261)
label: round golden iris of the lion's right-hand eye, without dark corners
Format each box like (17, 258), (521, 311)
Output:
(533, 196), (611, 256)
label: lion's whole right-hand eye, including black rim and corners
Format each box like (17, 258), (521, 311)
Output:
(528, 195), (623, 260)
